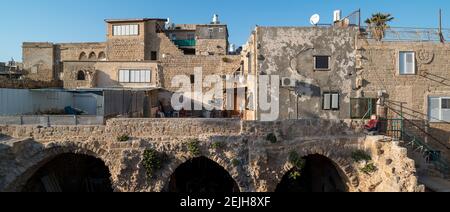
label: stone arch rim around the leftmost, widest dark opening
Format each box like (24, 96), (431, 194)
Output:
(5, 142), (118, 191)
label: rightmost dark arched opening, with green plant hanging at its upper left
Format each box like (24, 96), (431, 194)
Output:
(276, 155), (348, 192)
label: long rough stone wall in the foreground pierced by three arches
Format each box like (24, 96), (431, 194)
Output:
(0, 119), (423, 192)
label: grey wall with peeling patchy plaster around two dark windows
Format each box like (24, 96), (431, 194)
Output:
(255, 27), (357, 120)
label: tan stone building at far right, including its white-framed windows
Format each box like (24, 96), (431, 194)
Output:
(357, 34), (450, 164)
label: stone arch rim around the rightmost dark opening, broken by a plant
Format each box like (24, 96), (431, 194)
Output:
(276, 145), (359, 191)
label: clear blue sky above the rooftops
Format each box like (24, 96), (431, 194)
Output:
(0, 0), (450, 61)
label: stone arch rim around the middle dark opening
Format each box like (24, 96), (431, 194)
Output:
(161, 156), (243, 192)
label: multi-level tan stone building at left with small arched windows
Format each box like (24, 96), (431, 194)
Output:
(18, 15), (240, 118)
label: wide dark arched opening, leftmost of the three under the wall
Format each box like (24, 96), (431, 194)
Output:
(23, 153), (113, 192)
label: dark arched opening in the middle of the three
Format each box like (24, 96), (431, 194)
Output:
(167, 157), (239, 194)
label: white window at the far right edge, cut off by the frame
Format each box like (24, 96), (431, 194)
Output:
(428, 97), (450, 122)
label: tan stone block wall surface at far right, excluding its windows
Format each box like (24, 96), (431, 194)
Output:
(358, 39), (450, 158)
